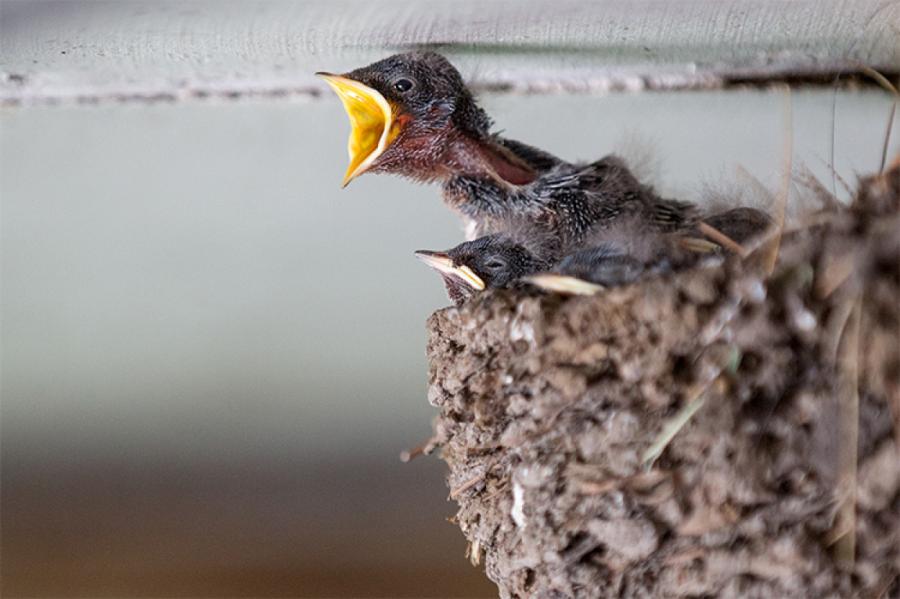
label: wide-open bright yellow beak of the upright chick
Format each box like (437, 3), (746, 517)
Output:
(316, 73), (399, 187)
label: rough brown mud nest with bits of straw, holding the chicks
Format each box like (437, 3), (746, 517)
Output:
(428, 167), (900, 598)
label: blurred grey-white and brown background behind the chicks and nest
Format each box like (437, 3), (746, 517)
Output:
(0, 0), (900, 597)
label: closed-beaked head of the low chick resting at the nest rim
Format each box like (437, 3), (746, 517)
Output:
(416, 234), (545, 305)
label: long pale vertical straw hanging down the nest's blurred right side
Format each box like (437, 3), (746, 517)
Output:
(834, 297), (862, 570)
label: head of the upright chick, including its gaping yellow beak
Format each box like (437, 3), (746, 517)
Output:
(317, 52), (491, 185)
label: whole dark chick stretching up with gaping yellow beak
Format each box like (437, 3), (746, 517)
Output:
(320, 52), (696, 250)
